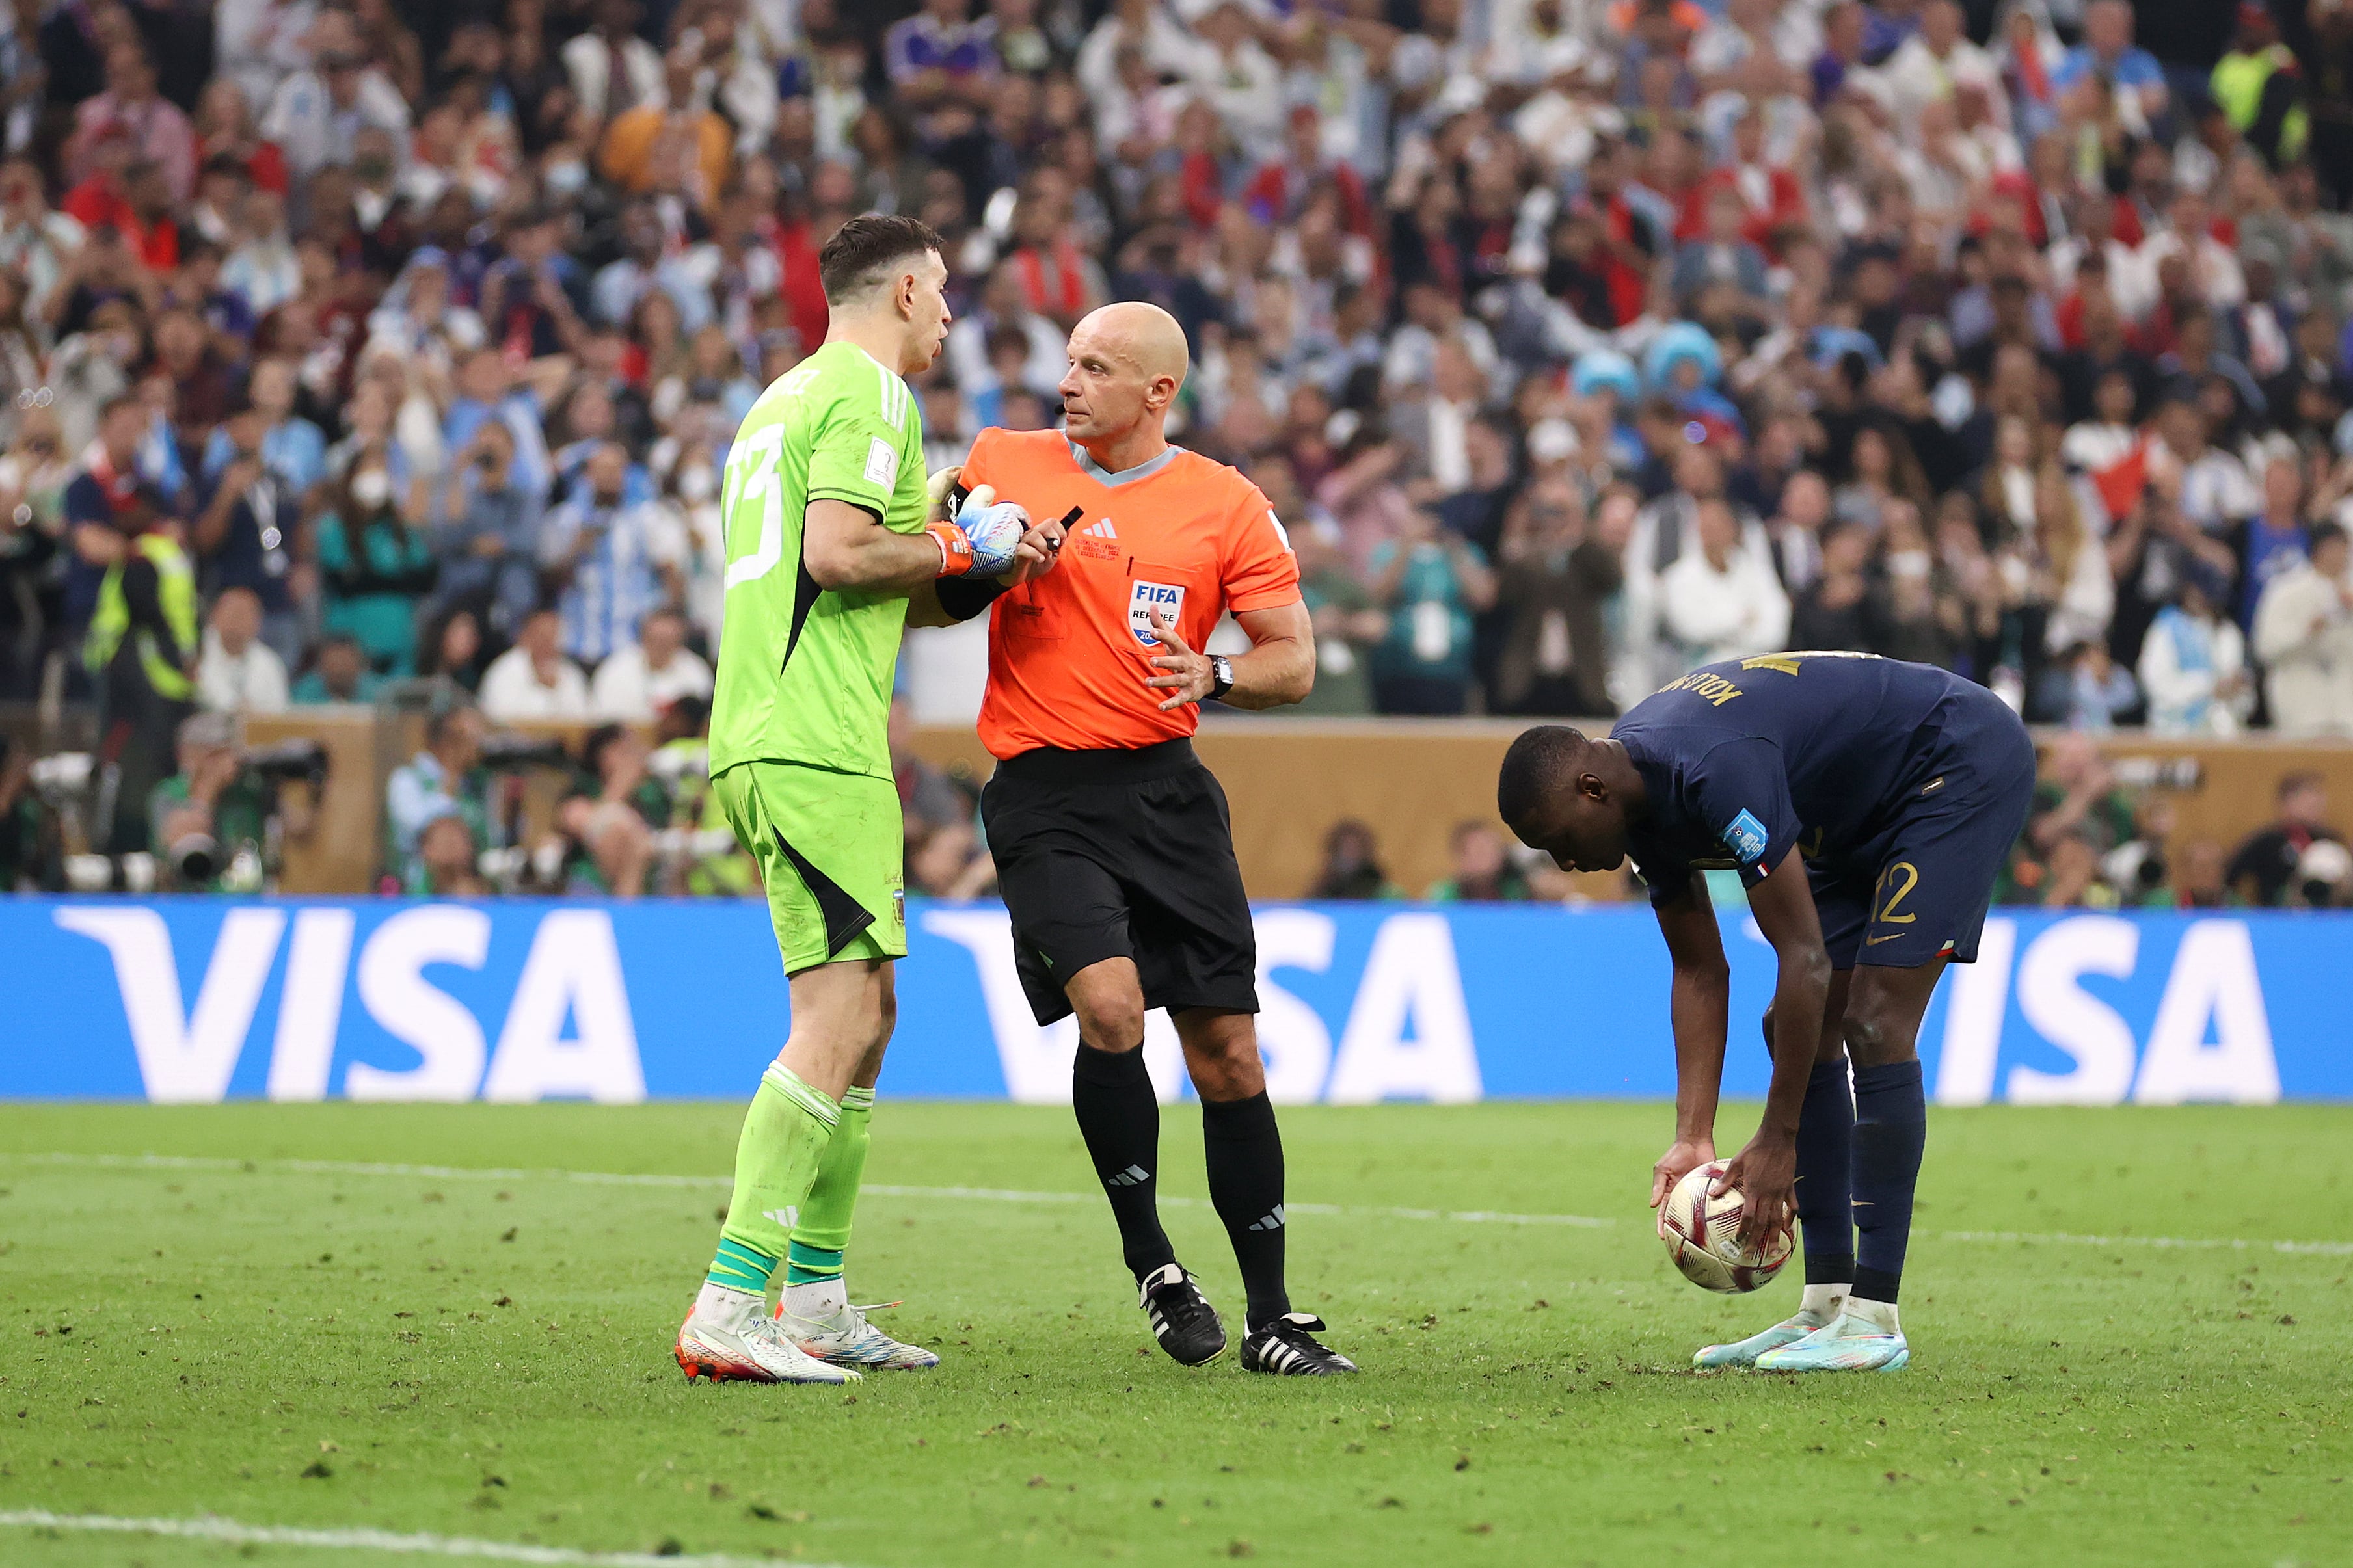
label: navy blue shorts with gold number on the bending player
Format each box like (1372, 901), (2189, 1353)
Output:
(1805, 689), (2036, 968)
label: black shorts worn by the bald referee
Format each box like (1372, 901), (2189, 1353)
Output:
(981, 741), (1259, 1025)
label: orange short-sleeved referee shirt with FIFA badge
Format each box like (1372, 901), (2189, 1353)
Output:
(960, 430), (1299, 757)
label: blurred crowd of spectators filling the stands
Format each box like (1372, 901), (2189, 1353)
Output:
(0, 0), (2353, 891)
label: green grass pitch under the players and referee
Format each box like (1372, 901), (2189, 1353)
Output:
(0, 1098), (2353, 1568)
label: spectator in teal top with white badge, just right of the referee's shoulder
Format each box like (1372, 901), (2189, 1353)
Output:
(1369, 508), (1494, 715)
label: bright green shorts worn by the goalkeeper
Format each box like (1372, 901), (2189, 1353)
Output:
(710, 762), (906, 976)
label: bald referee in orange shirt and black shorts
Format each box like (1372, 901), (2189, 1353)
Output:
(958, 303), (1355, 1375)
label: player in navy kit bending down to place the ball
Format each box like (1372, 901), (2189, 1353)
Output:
(1496, 654), (2036, 1373)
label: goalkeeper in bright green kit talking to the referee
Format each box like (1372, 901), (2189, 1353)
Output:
(678, 214), (1061, 1382)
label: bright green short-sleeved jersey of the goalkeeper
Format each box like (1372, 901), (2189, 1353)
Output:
(710, 343), (924, 778)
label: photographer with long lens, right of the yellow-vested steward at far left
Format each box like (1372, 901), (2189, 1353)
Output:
(148, 712), (325, 894)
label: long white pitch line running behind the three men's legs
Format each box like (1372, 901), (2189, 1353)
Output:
(18, 1154), (2353, 1258)
